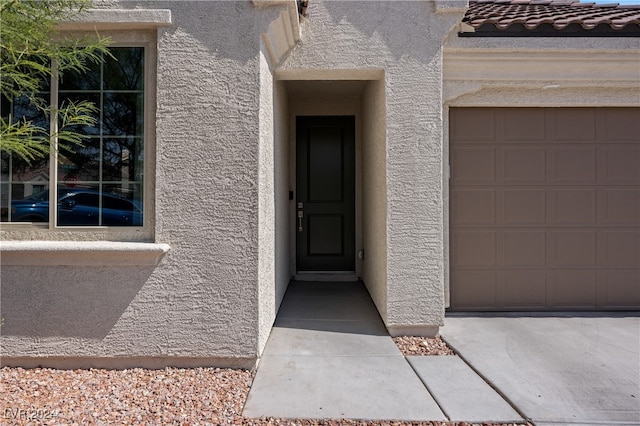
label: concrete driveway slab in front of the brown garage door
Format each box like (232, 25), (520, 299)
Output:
(440, 313), (640, 426)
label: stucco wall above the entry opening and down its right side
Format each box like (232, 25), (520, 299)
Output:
(281, 1), (460, 332)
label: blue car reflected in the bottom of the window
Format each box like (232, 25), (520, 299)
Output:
(11, 188), (142, 226)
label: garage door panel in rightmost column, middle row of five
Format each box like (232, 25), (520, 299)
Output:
(598, 188), (640, 227)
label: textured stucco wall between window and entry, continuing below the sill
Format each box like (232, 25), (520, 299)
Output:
(1, 1), (286, 366)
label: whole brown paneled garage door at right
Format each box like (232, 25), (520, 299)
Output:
(450, 108), (640, 311)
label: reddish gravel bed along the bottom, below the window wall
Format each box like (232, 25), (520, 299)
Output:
(0, 367), (528, 426)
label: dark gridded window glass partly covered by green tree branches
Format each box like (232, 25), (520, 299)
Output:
(0, 47), (145, 228)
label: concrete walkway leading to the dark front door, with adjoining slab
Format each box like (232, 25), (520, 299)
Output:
(243, 282), (522, 422)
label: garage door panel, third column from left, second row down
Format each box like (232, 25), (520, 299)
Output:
(550, 146), (597, 185)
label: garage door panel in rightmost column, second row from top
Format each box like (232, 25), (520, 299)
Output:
(598, 145), (640, 185)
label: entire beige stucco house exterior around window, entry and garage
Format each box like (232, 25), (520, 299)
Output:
(0, 0), (640, 367)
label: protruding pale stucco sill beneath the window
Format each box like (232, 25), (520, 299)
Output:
(0, 241), (170, 266)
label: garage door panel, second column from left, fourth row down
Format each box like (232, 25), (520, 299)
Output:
(501, 230), (547, 268)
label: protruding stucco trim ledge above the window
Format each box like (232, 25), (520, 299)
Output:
(57, 9), (172, 31)
